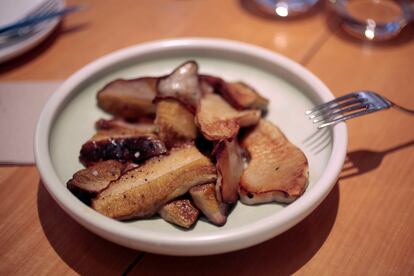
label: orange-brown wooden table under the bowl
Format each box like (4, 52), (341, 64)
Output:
(0, 0), (414, 275)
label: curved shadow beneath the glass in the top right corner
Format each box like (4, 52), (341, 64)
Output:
(325, 9), (414, 48)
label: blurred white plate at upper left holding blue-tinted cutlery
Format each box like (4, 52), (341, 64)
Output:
(0, 0), (65, 63)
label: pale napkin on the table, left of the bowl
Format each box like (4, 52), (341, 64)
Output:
(0, 81), (61, 164)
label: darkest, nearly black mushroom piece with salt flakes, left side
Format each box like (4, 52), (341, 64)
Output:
(79, 132), (167, 166)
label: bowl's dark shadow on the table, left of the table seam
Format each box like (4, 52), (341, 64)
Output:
(37, 182), (141, 275)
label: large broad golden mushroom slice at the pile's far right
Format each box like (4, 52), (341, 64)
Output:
(240, 120), (308, 204)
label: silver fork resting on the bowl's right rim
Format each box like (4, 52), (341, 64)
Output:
(305, 91), (414, 128)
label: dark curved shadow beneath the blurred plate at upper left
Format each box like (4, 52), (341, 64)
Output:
(0, 22), (88, 76)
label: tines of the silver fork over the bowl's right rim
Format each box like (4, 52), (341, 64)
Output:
(306, 93), (370, 128)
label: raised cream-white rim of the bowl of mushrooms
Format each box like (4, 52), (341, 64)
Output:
(34, 38), (347, 255)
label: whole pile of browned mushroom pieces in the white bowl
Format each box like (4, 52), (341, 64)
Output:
(67, 60), (309, 228)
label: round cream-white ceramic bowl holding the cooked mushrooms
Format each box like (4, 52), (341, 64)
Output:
(35, 39), (347, 255)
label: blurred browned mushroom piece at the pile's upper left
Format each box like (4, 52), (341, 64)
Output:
(97, 77), (158, 119)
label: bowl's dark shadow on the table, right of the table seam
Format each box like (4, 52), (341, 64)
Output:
(132, 185), (339, 275)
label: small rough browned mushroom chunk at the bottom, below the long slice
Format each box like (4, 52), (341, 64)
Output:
(158, 199), (200, 228)
